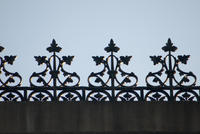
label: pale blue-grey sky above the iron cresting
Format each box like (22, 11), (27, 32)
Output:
(0, 0), (200, 86)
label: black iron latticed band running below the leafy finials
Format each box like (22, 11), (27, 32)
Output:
(0, 86), (200, 102)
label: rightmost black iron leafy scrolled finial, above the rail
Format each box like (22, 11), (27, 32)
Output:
(146, 39), (196, 87)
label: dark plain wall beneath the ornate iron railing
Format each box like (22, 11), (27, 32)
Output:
(0, 102), (200, 134)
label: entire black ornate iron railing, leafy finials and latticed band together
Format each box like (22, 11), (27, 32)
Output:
(0, 39), (200, 102)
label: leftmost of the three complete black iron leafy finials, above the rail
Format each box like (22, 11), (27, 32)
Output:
(30, 39), (80, 87)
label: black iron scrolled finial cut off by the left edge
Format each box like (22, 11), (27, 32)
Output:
(0, 46), (22, 87)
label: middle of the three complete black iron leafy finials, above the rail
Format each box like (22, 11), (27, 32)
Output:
(88, 39), (138, 87)
